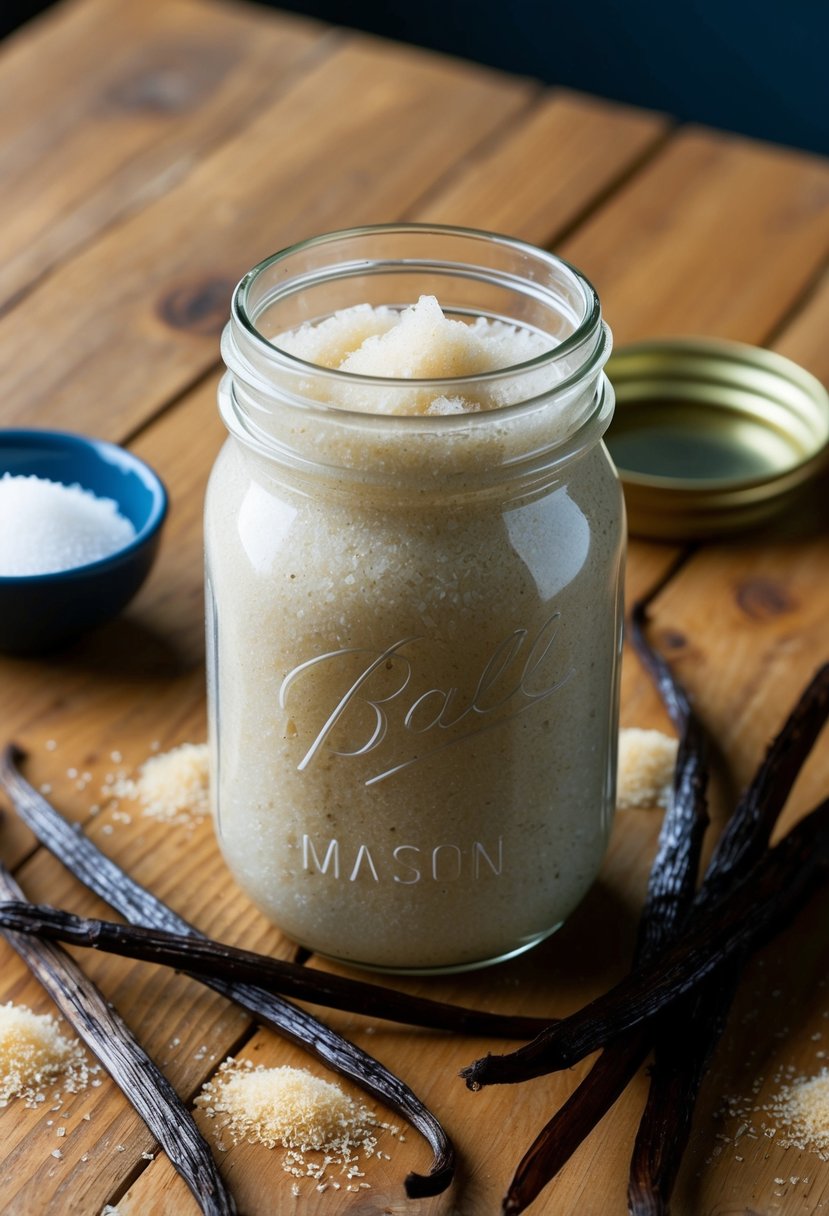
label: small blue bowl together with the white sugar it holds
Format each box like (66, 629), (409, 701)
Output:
(0, 429), (168, 654)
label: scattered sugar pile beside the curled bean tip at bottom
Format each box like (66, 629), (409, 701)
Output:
(196, 1057), (397, 1182)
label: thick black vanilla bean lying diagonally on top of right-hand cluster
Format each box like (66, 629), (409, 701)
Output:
(461, 799), (829, 1088)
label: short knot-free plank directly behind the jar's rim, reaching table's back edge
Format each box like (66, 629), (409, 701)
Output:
(411, 90), (669, 246)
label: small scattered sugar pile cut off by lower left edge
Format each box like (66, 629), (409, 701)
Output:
(0, 1001), (100, 1108)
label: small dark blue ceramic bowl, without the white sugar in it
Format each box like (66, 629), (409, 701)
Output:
(0, 429), (167, 654)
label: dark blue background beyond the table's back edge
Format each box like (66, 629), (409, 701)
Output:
(6, 0), (829, 154)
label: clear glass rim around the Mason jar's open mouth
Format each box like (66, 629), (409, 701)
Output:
(231, 223), (609, 386)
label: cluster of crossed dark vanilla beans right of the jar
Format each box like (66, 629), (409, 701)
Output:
(462, 589), (829, 1216)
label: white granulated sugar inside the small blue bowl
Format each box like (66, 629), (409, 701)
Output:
(0, 473), (135, 576)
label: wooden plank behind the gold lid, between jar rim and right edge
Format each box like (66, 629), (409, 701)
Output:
(560, 128), (829, 343)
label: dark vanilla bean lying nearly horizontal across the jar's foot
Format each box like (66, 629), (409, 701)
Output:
(0, 902), (549, 1038)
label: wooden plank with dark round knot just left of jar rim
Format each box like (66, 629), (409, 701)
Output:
(0, 39), (530, 447)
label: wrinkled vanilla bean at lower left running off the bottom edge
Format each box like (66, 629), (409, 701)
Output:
(0, 863), (236, 1216)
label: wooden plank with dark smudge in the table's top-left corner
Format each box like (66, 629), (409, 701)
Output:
(0, 0), (323, 309)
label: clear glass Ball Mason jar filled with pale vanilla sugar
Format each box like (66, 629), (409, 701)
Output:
(205, 225), (624, 973)
